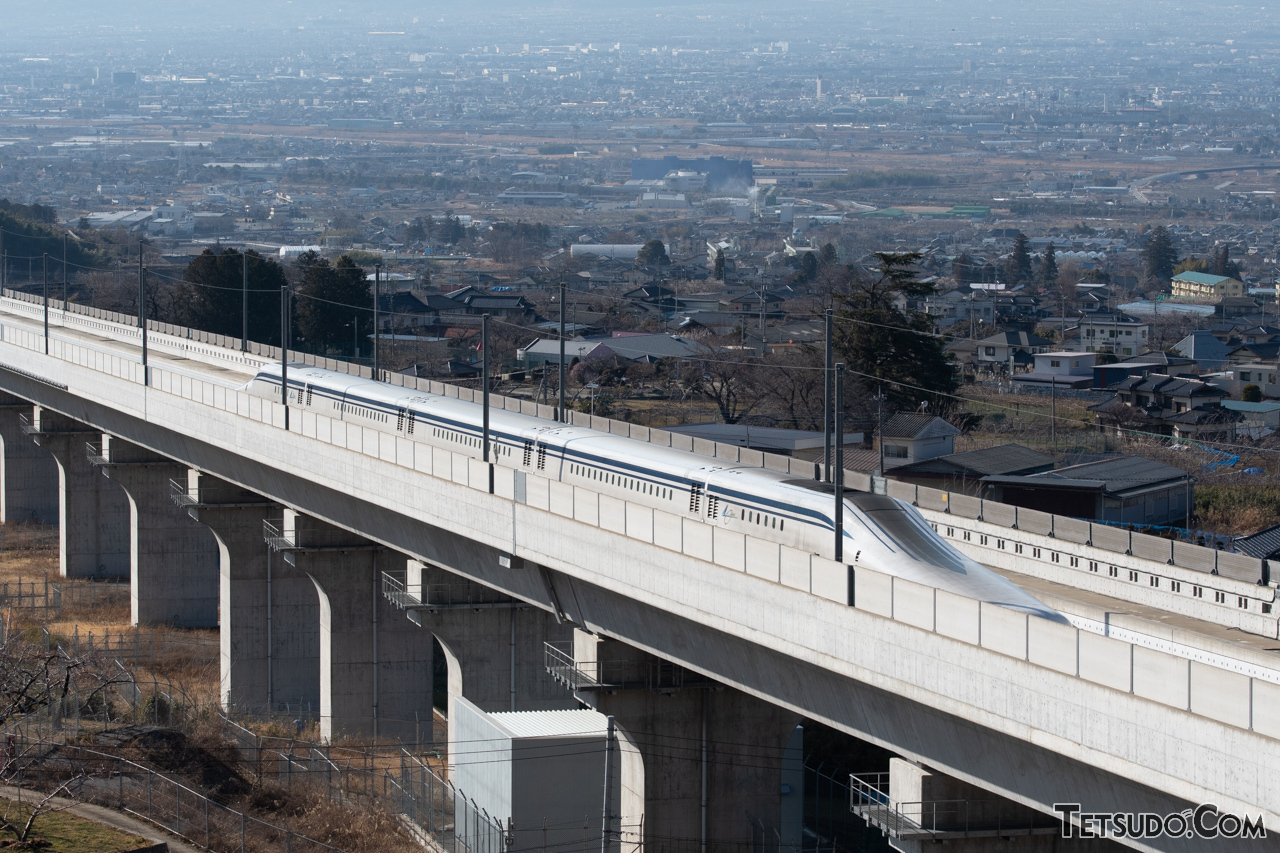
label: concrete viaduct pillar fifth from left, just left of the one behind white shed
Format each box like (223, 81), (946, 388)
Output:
(280, 510), (431, 739)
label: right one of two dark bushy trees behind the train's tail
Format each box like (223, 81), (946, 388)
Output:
(294, 252), (374, 352)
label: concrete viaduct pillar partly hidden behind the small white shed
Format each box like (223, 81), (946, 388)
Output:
(406, 560), (579, 754)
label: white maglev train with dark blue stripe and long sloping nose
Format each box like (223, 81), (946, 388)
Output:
(243, 364), (1065, 621)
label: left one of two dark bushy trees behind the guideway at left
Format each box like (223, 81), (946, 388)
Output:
(178, 248), (287, 345)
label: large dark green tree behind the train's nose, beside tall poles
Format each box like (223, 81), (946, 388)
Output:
(833, 252), (959, 414)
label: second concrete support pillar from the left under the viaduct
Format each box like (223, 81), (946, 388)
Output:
(24, 406), (129, 578)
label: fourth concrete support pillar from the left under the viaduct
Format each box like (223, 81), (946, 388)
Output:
(173, 469), (294, 715)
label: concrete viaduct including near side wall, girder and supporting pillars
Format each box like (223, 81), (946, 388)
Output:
(0, 293), (1280, 850)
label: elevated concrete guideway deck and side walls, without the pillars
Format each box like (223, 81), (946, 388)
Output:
(0, 290), (1280, 850)
